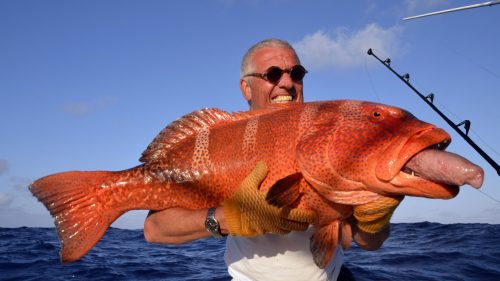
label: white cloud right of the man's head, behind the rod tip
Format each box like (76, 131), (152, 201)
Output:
(293, 23), (403, 69)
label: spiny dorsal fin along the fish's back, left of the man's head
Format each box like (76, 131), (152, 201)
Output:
(139, 108), (272, 163)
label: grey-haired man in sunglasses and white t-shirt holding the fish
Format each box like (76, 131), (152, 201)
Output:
(144, 39), (400, 280)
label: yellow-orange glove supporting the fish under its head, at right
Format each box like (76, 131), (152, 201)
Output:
(354, 196), (404, 234)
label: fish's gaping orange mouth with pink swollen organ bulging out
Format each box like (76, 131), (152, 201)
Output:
(377, 127), (484, 199)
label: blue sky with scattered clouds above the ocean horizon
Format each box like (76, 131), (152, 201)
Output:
(0, 0), (500, 228)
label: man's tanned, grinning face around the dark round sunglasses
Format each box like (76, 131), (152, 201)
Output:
(240, 47), (304, 109)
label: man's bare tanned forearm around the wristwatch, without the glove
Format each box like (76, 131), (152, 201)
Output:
(144, 207), (228, 244)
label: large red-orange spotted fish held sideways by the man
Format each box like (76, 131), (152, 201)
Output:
(30, 100), (483, 267)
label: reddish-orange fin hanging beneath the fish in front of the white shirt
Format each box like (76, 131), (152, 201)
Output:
(310, 221), (342, 268)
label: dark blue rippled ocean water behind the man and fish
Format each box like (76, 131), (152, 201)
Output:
(0, 222), (500, 281)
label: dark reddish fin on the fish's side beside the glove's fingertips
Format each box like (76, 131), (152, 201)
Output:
(266, 173), (302, 207)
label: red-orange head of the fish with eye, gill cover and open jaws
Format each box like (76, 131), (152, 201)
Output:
(297, 100), (458, 203)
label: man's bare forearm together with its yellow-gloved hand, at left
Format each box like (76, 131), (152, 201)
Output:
(144, 162), (316, 244)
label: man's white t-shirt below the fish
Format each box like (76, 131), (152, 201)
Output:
(224, 227), (344, 281)
